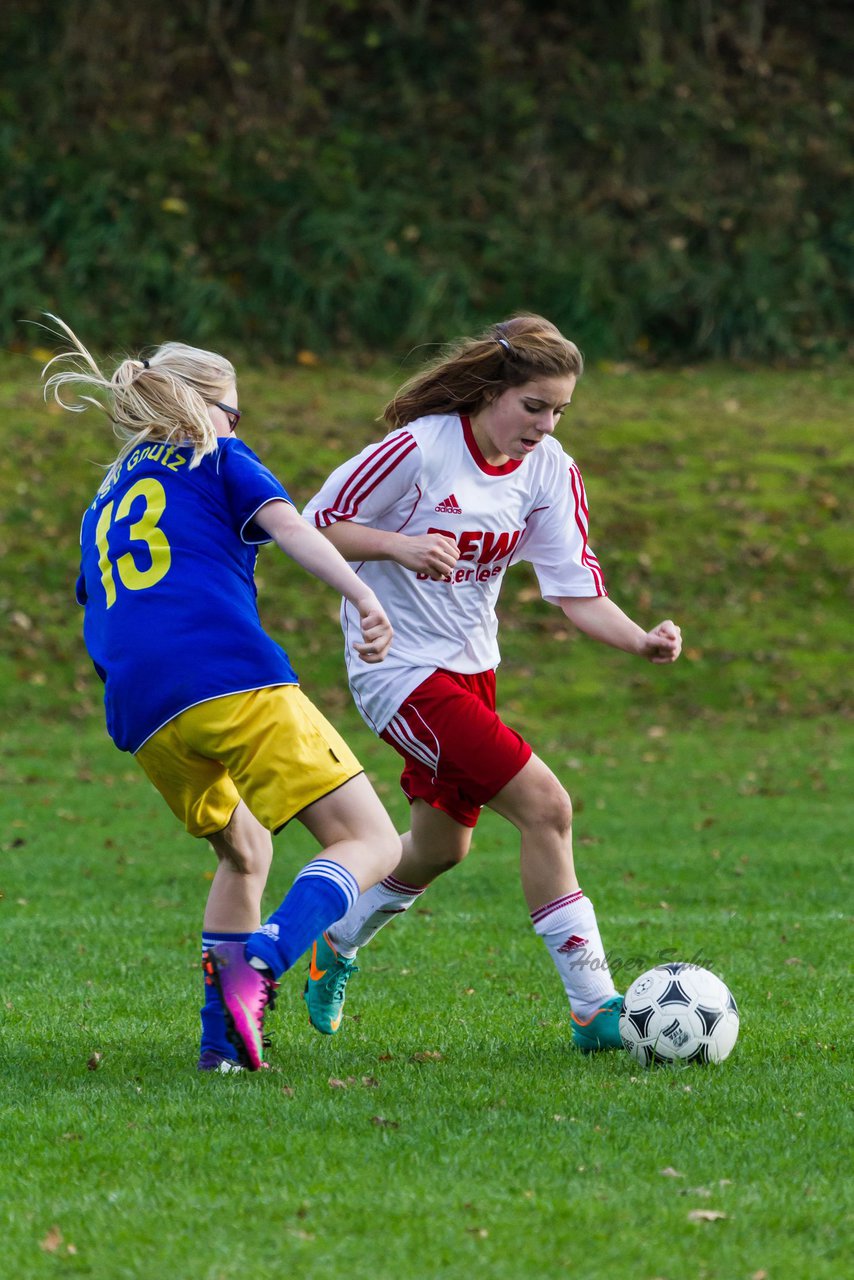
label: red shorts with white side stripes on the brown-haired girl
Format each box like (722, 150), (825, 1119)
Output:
(380, 671), (531, 827)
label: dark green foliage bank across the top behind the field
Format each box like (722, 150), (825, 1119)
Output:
(0, 0), (854, 358)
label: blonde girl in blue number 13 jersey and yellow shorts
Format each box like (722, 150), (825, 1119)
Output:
(45, 316), (401, 1070)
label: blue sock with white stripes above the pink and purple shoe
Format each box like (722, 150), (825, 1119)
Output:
(246, 858), (359, 978)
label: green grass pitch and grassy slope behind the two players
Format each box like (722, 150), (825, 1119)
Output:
(0, 357), (854, 1280)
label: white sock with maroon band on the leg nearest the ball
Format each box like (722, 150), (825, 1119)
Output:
(531, 890), (617, 1019)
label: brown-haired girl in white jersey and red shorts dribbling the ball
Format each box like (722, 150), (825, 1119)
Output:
(303, 315), (681, 1050)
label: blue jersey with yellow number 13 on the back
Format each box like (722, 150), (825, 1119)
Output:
(77, 436), (297, 751)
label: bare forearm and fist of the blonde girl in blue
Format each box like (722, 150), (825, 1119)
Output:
(252, 500), (393, 662)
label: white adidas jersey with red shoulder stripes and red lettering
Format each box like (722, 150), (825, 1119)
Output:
(303, 413), (607, 733)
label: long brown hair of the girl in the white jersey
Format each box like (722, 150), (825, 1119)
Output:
(383, 315), (584, 428)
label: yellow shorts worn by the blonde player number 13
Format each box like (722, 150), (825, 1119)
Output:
(136, 685), (362, 836)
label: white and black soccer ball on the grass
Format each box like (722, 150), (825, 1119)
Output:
(620, 964), (739, 1066)
